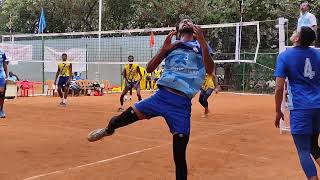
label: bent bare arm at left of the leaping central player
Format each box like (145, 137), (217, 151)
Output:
(146, 31), (179, 73)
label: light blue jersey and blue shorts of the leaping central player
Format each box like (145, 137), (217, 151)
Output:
(135, 41), (212, 136)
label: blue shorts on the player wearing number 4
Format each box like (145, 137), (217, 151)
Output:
(290, 109), (320, 135)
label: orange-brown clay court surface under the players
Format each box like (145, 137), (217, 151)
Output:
(0, 93), (305, 180)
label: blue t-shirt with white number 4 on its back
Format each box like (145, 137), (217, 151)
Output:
(274, 47), (320, 110)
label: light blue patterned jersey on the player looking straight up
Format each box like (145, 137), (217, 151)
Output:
(157, 41), (212, 99)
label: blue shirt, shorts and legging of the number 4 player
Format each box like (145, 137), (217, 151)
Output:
(274, 47), (320, 179)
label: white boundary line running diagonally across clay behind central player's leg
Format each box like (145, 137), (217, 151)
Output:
(23, 121), (268, 180)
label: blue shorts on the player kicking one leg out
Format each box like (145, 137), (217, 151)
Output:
(134, 87), (192, 136)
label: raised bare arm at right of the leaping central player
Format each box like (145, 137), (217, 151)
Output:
(193, 26), (214, 74)
